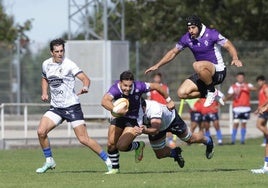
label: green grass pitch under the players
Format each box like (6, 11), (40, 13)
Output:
(0, 138), (268, 188)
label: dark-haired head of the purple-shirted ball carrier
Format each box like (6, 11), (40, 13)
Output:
(119, 71), (134, 96)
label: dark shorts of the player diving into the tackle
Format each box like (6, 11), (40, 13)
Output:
(149, 111), (187, 141)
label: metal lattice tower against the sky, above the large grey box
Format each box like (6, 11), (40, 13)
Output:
(68, 0), (125, 40)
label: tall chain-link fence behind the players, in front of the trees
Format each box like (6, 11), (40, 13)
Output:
(0, 41), (268, 112)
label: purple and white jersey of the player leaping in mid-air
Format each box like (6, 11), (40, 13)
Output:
(176, 25), (228, 71)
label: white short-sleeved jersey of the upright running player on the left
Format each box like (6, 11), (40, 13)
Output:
(42, 58), (82, 108)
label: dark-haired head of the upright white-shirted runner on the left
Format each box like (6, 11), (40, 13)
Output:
(49, 39), (65, 63)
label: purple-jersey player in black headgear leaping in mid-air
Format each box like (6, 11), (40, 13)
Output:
(145, 16), (242, 107)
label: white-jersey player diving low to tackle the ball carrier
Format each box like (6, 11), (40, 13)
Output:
(137, 100), (214, 168)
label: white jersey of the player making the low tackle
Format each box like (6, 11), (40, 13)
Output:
(145, 100), (176, 131)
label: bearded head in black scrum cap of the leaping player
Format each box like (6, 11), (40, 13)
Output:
(186, 15), (202, 38)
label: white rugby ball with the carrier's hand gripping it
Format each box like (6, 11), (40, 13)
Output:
(111, 98), (129, 117)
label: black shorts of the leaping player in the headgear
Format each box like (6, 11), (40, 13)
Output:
(188, 68), (226, 98)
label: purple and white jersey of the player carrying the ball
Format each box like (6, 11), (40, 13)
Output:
(107, 81), (150, 119)
